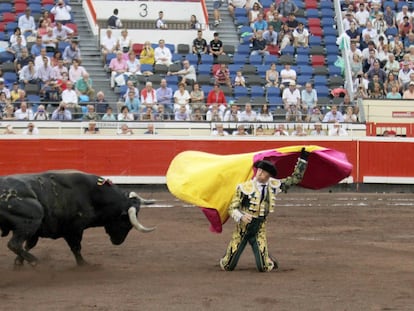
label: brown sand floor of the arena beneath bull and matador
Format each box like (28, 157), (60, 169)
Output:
(0, 191), (414, 311)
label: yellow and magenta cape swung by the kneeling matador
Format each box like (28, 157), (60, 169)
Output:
(167, 146), (352, 232)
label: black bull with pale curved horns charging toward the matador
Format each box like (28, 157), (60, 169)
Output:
(0, 171), (154, 265)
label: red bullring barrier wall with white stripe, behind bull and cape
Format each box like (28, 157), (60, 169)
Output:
(0, 135), (414, 184)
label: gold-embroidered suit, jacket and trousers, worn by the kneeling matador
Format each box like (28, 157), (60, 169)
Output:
(220, 159), (307, 272)
